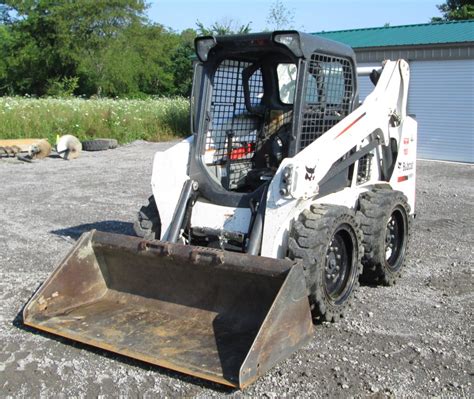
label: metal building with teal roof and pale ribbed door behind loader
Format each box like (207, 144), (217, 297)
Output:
(316, 20), (474, 163)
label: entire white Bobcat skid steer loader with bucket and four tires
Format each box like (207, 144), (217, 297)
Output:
(24, 31), (417, 388)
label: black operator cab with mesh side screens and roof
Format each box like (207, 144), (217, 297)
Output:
(190, 31), (355, 205)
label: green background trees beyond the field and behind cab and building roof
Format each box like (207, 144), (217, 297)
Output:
(0, 0), (473, 98)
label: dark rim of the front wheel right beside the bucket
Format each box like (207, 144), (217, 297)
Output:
(324, 226), (355, 304)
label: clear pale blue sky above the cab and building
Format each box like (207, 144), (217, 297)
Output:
(148, 0), (444, 32)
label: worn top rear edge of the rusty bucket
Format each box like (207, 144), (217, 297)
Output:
(92, 231), (299, 277)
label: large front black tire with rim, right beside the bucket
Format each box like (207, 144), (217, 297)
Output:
(288, 205), (363, 321)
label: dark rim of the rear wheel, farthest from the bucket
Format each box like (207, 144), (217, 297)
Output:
(385, 207), (407, 271)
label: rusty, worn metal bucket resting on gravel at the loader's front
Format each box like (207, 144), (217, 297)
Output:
(23, 231), (313, 388)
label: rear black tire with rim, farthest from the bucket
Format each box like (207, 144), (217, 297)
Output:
(357, 188), (412, 285)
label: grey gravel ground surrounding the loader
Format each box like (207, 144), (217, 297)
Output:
(0, 142), (474, 398)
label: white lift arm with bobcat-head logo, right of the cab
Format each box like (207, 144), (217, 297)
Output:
(275, 60), (410, 199)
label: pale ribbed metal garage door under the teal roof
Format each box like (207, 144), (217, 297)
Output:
(359, 60), (474, 163)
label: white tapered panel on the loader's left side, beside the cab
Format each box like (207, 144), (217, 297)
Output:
(151, 136), (193, 240)
